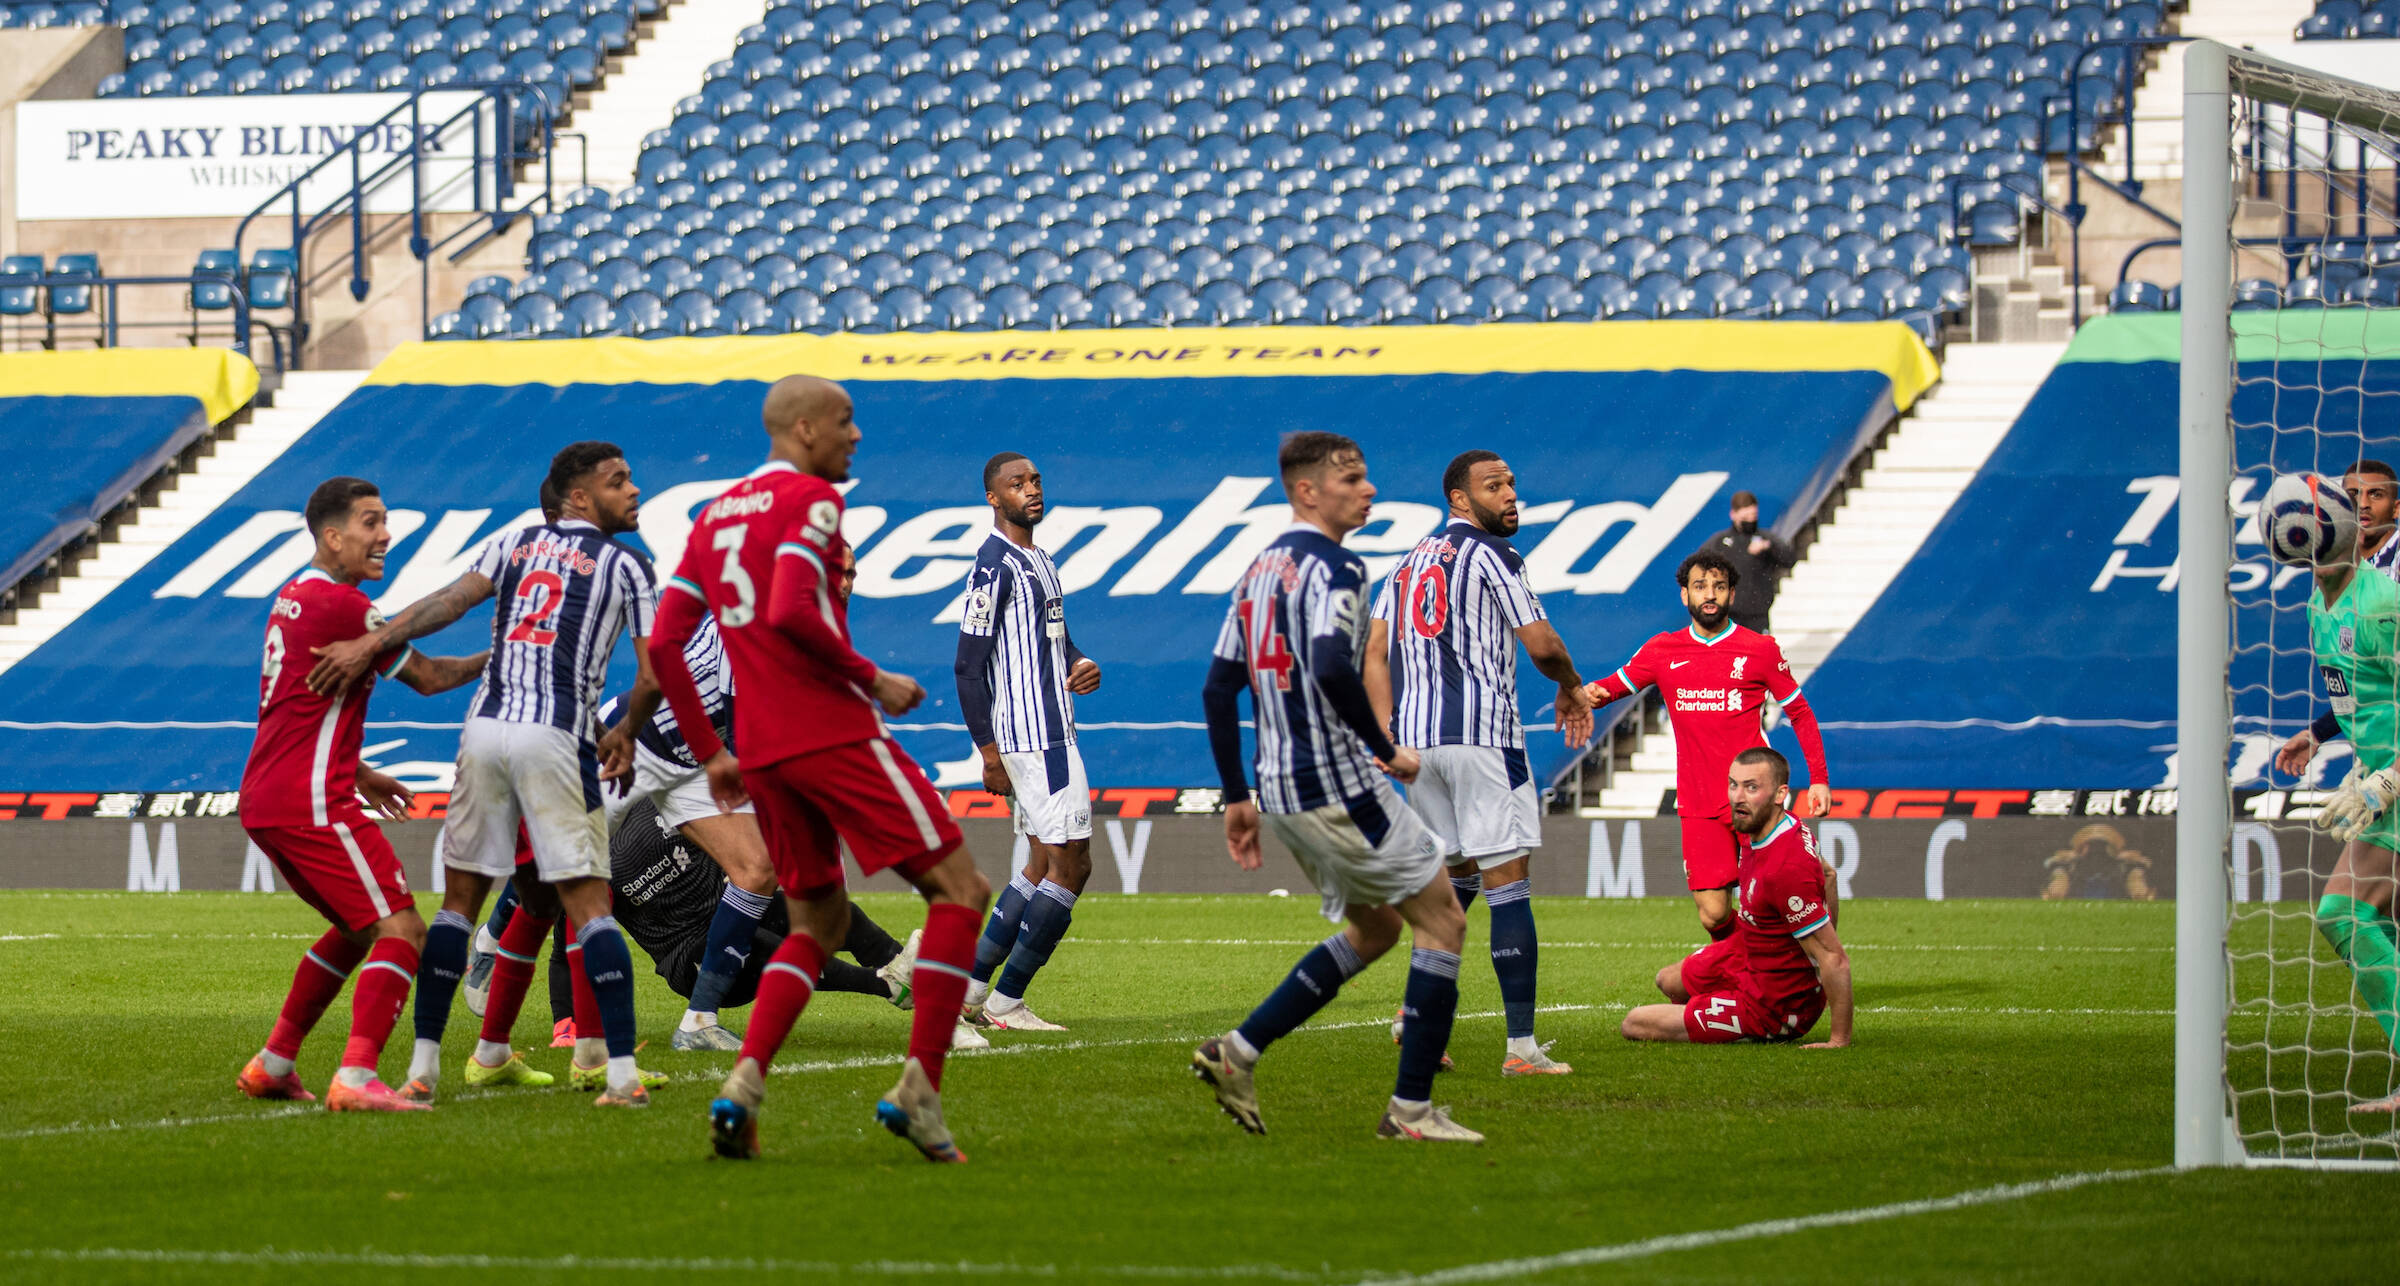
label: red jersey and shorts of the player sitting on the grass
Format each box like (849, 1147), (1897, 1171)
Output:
(1682, 813), (1834, 1044)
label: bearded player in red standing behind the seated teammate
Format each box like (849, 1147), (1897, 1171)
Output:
(1586, 549), (1834, 941)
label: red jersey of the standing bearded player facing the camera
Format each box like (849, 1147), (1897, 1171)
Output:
(1603, 624), (1800, 821)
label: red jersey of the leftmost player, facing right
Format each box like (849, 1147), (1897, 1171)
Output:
(242, 566), (408, 825)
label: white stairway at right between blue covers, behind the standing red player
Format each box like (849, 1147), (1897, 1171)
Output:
(1584, 343), (2066, 818)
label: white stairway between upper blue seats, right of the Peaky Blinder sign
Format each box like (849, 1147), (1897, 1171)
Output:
(576, 0), (766, 192)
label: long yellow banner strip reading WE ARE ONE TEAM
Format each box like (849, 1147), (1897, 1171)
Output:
(367, 322), (1942, 410)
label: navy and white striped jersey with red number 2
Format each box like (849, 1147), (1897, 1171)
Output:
(470, 518), (658, 741)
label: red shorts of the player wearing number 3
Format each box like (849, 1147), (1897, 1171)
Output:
(742, 737), (960, 897)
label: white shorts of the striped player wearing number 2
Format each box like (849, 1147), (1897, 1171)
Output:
(442, 717), (607, 883)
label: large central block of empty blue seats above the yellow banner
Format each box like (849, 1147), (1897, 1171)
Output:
(393, 0), (2160, 338)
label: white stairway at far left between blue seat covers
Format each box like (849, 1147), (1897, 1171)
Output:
(0, 369), (367, 672)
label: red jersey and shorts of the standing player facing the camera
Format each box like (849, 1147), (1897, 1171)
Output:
(1598, 621), (1826, 890)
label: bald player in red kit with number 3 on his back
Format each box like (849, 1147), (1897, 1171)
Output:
(650, 374), (991, 1161)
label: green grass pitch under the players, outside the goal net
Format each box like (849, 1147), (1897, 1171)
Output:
(0, 893), (2400, 1284)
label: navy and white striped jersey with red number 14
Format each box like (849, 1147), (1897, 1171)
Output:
(1217, 523), (1375, 813)
